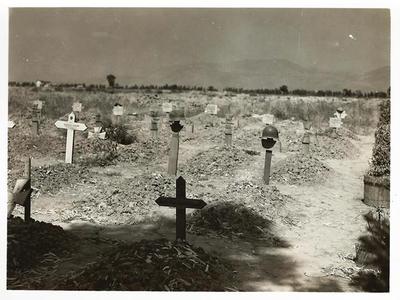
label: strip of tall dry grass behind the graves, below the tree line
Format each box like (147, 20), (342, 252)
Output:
(8, 87), (382, 135)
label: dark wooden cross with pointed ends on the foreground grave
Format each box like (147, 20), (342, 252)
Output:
(156, 176), (207, 241)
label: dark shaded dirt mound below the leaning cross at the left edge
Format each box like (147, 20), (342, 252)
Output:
(7, 218), (74, 275)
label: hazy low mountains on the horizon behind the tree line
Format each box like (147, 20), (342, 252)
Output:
(123, 59), (390, 91)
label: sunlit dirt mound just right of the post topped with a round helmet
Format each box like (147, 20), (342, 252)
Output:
(271, 154), (331, 184)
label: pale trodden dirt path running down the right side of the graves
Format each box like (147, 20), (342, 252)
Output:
(209, 137), (372, 291)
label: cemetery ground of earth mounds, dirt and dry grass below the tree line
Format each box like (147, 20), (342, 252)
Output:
(7, 88), (380, 291)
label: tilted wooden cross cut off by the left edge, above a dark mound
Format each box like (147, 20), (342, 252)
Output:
(7, 157), (32, 222)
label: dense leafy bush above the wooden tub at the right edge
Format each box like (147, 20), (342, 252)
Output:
(368, 100), (390, 176)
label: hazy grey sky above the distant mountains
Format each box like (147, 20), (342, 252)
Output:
(9, 8), (390, 82)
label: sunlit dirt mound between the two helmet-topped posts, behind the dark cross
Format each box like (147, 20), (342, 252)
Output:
(180, 147), (252, 179)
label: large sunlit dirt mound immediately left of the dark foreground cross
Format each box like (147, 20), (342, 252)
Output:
(74, 174), (175, 224)
